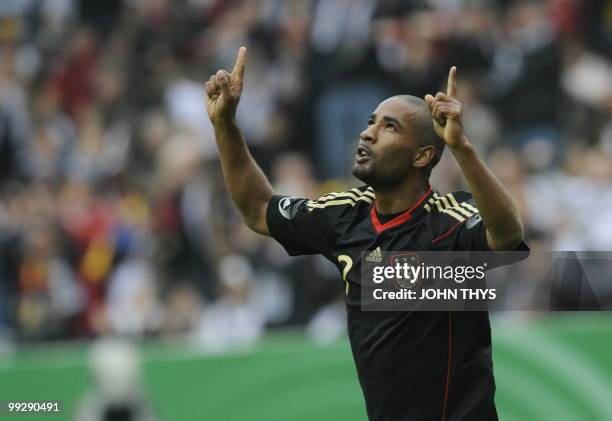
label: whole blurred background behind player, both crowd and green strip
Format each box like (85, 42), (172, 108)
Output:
(0, 0), (612, 420)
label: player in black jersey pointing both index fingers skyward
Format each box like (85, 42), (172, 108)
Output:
(205, 47), (526, 421)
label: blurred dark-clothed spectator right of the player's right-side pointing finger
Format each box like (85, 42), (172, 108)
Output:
(489, 1), (561, 164)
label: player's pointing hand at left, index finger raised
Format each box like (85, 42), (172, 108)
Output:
(204, 47), (246, 124)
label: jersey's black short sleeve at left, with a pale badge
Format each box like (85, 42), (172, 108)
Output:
(266, 195), (332, 256)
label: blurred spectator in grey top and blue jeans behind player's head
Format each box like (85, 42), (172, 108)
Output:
(314, 0), (388, 178)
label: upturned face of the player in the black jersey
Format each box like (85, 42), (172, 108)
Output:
(352, 97), (419, 191)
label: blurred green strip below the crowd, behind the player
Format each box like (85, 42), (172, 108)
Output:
(0, 313), (612, 421)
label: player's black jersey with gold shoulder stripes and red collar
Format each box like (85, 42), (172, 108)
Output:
(267, 186), (528, 421)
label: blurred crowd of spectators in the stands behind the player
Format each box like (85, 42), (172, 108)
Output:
(0, 0), (612, 342)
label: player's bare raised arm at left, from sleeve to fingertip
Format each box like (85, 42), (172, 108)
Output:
(204, 47), (274, 235)
